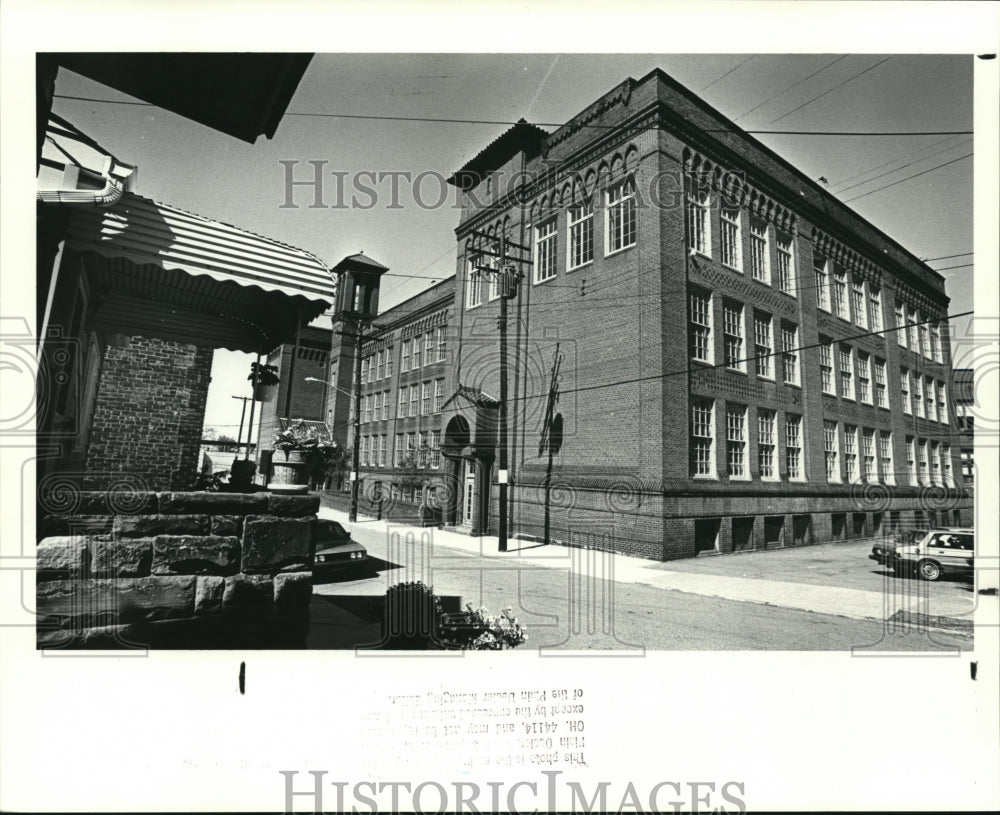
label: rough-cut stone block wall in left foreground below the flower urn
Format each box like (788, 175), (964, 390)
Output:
(36, 492), (319, 649)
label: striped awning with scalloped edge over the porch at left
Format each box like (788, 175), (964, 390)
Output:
(66, 193), (336, 352)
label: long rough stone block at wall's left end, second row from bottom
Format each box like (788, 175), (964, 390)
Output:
(36, 575), (196, 629)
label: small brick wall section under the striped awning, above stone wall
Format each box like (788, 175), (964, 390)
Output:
(84, 337), (213, 490)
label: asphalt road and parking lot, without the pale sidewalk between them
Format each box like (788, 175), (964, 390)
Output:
(309, 523), (972, 652)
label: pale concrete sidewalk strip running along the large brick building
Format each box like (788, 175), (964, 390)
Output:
(319, 507), (980, 633)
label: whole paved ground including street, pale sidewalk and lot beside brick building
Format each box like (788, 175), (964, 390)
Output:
(309, 509), (976, 653)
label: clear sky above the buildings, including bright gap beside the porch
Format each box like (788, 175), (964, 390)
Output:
(53, 51), (975, 435)
